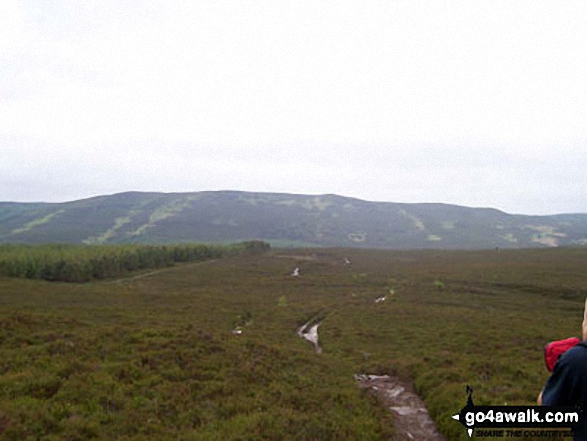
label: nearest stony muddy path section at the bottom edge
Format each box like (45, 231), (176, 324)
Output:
(355, 375), (446, 441)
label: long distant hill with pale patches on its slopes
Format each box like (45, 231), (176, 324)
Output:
(0, 191), (587, 249)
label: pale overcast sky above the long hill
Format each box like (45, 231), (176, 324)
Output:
(0, 0), (587, 214)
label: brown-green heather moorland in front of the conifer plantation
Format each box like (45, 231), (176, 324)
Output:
(0, 248), (587, 440)
